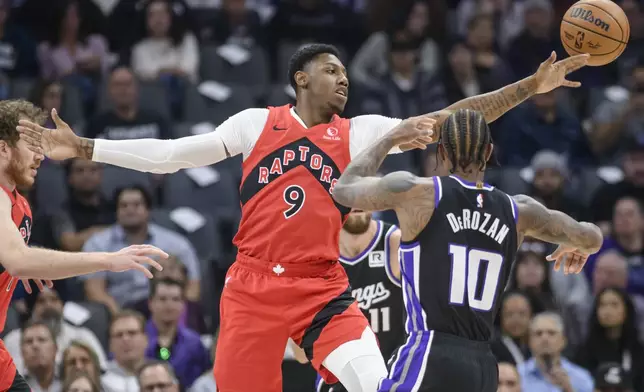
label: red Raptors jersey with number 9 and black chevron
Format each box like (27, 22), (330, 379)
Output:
(234, 105), (350, 263)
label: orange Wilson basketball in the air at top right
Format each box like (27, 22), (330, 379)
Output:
(559, 0), (631, 66)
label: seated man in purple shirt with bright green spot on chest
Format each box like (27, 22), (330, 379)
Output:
(145, 279), (211, 387)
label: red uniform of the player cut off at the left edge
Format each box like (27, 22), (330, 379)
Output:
(0, 186), (32, 384)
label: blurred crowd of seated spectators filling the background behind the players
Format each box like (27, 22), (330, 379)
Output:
(0, 0), (644, 392)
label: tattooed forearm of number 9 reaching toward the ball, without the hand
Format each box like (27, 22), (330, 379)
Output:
(447, 77), (537, 123)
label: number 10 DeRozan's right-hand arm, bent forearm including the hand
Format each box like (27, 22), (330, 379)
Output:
(513, 195), (603, 272)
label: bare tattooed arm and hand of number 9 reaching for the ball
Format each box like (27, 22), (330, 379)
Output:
(432, 52), (588, 124)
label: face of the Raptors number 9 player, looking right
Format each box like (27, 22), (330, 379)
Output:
(307, 54), (349, 114)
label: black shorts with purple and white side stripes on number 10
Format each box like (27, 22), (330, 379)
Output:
(378, 331), (499, 392)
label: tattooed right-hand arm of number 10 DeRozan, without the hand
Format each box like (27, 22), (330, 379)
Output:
(513, 195), (603, 254)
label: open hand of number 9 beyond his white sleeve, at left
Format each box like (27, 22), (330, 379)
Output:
(16, 109), (81, 161)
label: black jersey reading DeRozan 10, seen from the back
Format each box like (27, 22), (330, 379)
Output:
(400, 176), (518, 341)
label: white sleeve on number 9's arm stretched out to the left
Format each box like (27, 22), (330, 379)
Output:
(92, 109), (268, 173)
